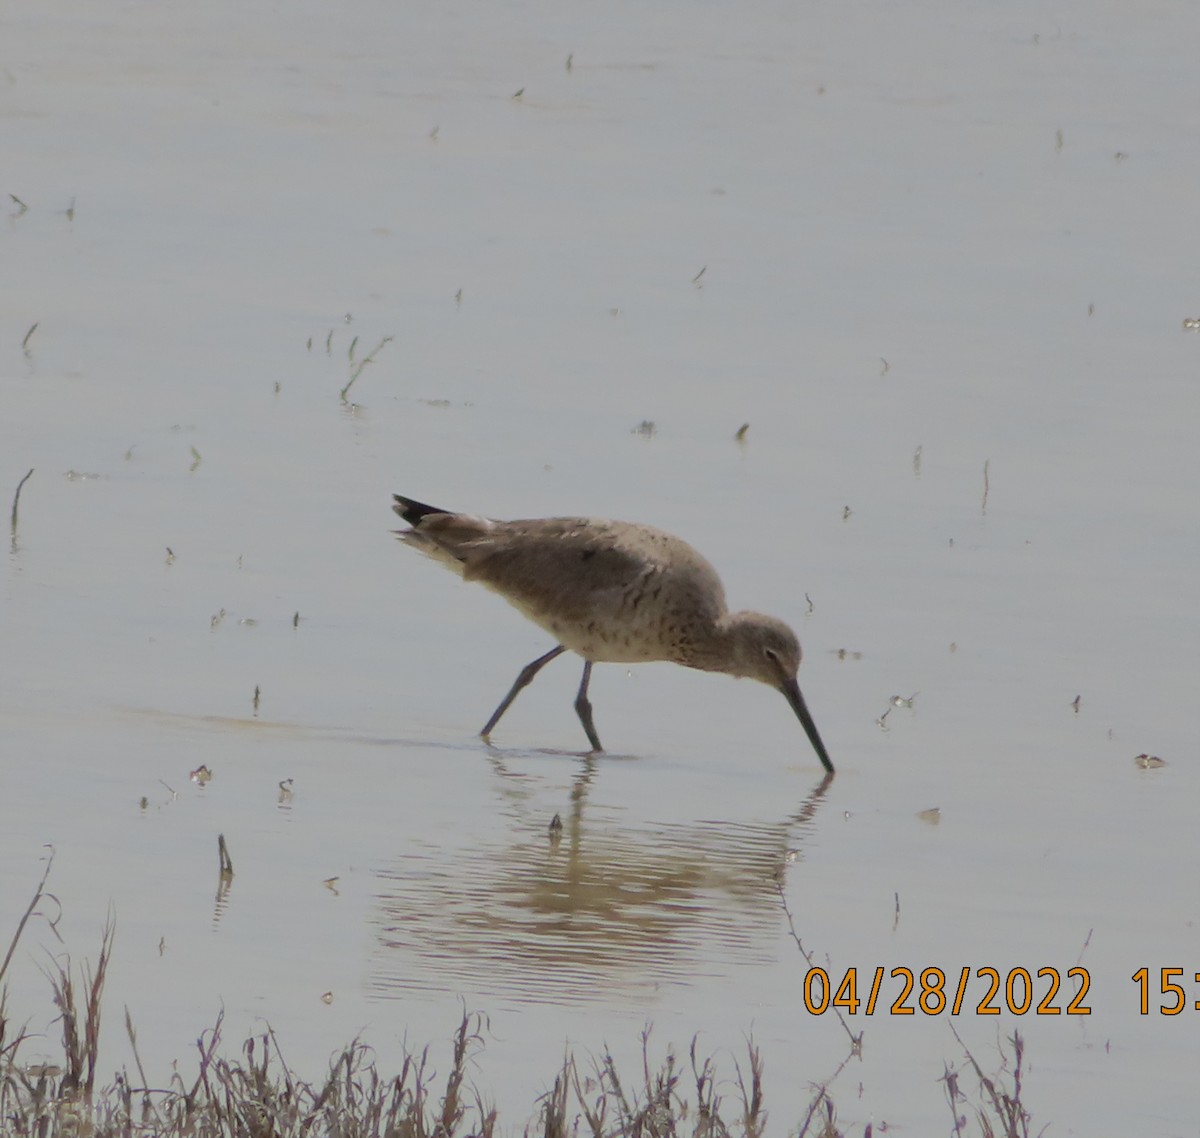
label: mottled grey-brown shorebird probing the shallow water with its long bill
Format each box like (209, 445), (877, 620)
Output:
(392, 493), (833, 773)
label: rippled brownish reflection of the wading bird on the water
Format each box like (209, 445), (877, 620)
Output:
(368, 754), (832, 1002)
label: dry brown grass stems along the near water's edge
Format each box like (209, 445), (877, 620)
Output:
(0, 852), (1039, 1138)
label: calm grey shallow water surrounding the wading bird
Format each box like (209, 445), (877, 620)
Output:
(0, 4), (1200, 1136)
